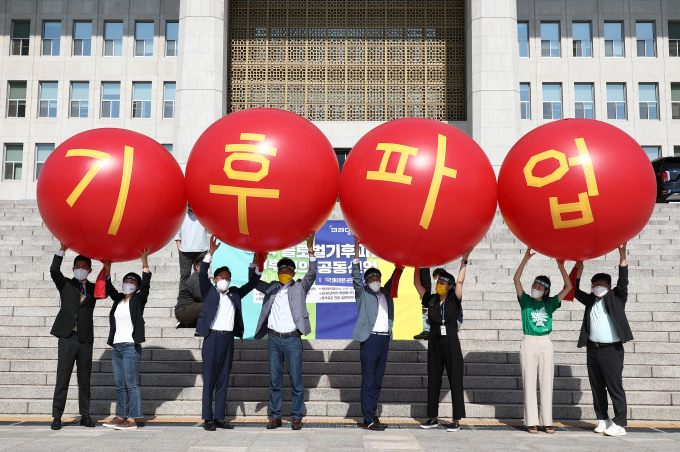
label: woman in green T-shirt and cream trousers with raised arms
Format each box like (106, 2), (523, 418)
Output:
(515, 248), (572, 433)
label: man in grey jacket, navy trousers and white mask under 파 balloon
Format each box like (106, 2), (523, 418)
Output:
(352, 237), (400, 431)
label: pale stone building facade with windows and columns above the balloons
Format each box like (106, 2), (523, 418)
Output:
(0, 0), (680, 199)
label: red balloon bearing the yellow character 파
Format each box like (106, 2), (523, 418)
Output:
(340, 118), (496, 267)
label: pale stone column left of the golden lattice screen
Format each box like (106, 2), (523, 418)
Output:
(173, 0), (227, 168)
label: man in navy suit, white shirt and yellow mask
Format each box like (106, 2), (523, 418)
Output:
(196, 236), (261, 431)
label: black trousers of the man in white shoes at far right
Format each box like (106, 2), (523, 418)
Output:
(587, 342), (628, 427)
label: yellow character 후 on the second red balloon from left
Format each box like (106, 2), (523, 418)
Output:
(210, 133), (279, 235)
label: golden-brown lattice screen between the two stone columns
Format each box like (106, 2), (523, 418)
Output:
(227, 0), (466, 121)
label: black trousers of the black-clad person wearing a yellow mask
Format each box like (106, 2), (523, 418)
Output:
(427, 325), (465, 419)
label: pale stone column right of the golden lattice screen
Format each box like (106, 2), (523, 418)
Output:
(465, 0), (520, 174)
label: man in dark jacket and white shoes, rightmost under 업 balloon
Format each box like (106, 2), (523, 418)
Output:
(574, 243), (633, 436)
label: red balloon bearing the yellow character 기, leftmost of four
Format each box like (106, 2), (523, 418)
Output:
(38, 129), (187, 262)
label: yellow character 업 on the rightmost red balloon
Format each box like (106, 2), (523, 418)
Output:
(524, 138), (600, 229)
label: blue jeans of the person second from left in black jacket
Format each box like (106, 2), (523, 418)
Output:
(112, 342), (142, 419)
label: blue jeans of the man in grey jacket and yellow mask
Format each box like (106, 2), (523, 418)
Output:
(267, 333), (305, 419)
